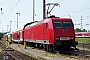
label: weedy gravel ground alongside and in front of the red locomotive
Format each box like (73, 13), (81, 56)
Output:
(0, 38), (90, 60)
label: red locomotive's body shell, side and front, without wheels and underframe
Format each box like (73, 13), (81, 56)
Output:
(24, 18), (75, 45)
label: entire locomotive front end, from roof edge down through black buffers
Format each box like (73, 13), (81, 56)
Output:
(51, 18), (78, 51)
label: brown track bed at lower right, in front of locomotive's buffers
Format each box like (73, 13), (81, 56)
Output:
(61, 49), (90, 60)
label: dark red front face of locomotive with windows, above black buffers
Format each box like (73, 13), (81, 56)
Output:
(53, 21), (75, 41)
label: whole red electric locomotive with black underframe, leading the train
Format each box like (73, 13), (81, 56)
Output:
(22, 16), (78, 51)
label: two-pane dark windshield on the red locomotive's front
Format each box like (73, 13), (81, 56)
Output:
(53, 22), (73, 28)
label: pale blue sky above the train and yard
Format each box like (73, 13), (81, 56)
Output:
(0, 0), (90, 32)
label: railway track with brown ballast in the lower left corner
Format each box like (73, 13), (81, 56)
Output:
(0, 42), (37, 60)
